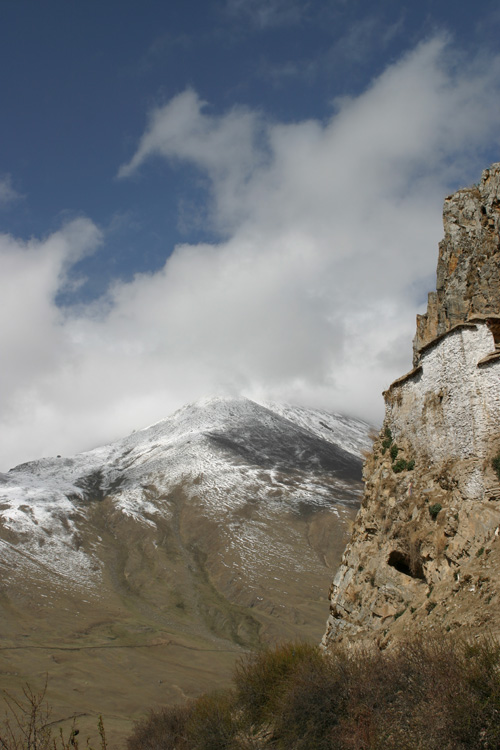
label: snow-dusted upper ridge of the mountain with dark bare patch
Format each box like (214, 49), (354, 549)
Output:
(0, 398), (368, 592)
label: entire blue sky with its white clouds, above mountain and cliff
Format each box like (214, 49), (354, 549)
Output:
(0, 0), (500, 469)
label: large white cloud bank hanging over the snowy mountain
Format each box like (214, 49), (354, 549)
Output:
(0, 39), (500, 468)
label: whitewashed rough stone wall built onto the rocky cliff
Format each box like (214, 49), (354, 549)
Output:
(386, 323), (500, 470)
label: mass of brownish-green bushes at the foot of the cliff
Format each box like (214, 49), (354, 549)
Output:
(127, 635), (500, 750)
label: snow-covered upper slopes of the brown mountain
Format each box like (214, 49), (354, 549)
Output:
(0, 398), (370, 587)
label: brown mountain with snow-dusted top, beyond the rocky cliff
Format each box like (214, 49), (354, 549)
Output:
(0, 398), (371, 740)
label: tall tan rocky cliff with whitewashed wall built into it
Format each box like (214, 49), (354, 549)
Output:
(324, 164), (500, 646)
